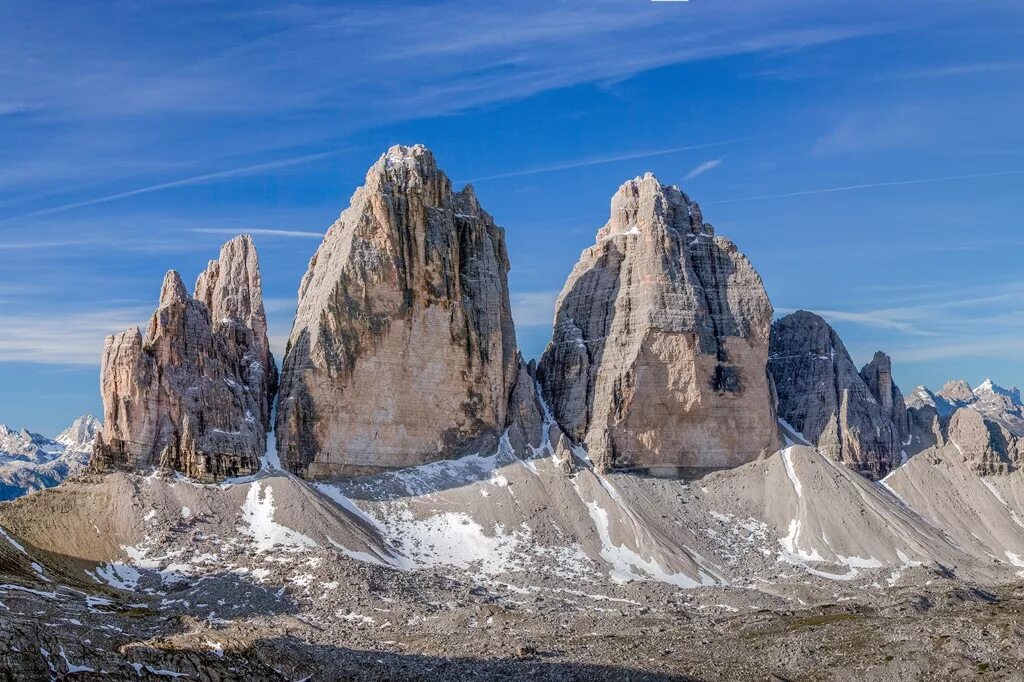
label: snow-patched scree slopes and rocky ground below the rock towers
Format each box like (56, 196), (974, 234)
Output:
(6, 440), (1024, 681)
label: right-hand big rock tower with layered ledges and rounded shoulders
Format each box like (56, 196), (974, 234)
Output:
(539, 173), (779, 475)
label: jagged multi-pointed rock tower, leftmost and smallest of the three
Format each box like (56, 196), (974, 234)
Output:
(91, 237), (278, 481)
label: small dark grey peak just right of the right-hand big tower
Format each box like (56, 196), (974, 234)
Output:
(768, 310), (909, 479)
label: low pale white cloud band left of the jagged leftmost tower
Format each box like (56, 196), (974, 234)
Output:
(0, 306), (152, 365)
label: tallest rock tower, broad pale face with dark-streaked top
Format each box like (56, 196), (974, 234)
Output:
(276, 145), (518, 478)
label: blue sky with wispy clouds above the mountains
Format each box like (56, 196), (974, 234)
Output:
(0, 0), (1024, 434)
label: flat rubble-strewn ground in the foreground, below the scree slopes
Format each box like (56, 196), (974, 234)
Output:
(0, 558), (1024, 680)
